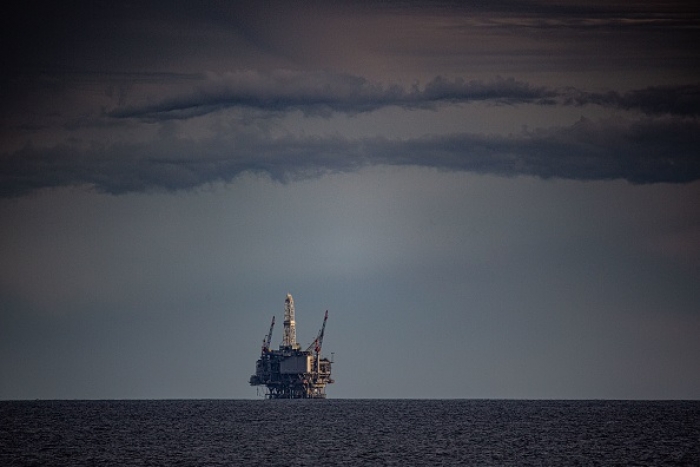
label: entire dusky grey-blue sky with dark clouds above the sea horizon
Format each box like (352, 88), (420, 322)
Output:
(0, 0), (700, 399)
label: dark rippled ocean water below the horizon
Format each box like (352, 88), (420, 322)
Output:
(0, 399), (700, 467)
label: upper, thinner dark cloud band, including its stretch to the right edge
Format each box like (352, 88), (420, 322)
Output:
(102, 71), (700, 121)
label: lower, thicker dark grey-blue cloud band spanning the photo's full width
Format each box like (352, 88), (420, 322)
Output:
(0, 118), (700, 197)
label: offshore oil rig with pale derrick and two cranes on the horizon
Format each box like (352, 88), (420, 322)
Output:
(250, 294), (333, 399)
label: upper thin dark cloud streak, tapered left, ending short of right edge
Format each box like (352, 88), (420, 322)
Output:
(109, 71), (556, 120)
